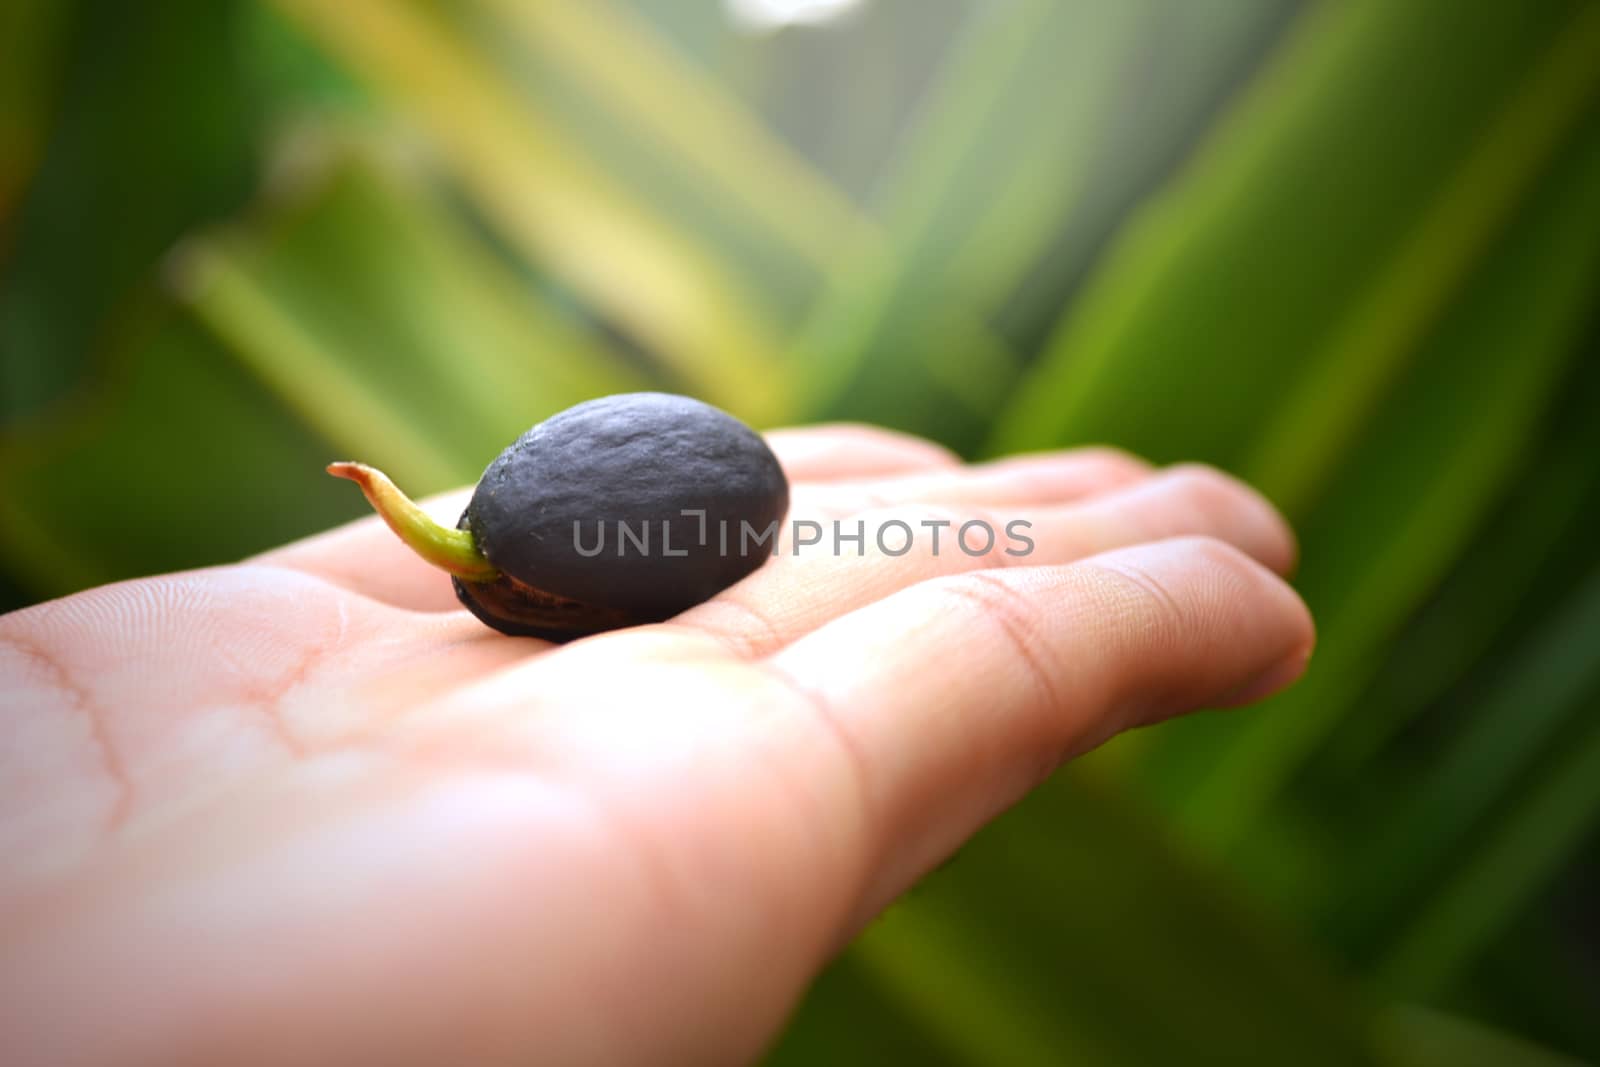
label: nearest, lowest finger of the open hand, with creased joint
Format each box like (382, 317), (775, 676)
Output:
(765, 537), (1314, 917)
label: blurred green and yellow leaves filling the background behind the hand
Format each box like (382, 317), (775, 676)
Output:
(0, 0), (1600, 1064)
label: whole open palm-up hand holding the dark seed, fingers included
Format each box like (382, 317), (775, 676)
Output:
(0, 427), (1314, 1065)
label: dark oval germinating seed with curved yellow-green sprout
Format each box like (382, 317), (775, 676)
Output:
(328, 392), (789, 641)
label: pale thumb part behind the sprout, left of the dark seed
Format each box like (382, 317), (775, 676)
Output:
(246, 490), (472, 611)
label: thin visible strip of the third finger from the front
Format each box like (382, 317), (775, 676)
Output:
(794, 448), (1150, 517)
